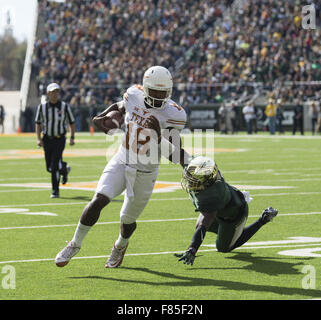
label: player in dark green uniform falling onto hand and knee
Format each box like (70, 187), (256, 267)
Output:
(175, 156), (278, 265)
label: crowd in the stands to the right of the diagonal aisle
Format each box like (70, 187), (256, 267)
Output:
(178, 0), (321, 100)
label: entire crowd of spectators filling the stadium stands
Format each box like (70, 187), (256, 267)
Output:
(33, 0), (321, 115)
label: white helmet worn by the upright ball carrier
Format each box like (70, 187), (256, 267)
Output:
(143, 66), (173, 109)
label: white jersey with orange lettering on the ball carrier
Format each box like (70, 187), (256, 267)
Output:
(116, 85), (186, 172)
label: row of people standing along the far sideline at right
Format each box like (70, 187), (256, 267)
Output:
(216, 95), (321, 135)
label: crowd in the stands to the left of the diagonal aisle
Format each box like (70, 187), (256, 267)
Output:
(33, 0), (231, 105)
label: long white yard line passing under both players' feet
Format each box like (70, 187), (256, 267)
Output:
(0, 237), (321, 264)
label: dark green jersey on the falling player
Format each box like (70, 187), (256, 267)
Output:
(190, 175), (246, 220)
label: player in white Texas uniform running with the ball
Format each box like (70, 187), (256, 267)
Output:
(55, 66), (190, 268)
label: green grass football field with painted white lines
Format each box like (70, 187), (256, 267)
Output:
(0, 134), (321, 300)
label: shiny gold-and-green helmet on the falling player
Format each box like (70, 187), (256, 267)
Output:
(181, 156), (218, 192)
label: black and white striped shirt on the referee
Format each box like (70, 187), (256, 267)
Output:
(35, 101), (75, 137)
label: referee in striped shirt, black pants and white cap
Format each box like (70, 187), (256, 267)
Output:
(35, 83), (75, 198)
